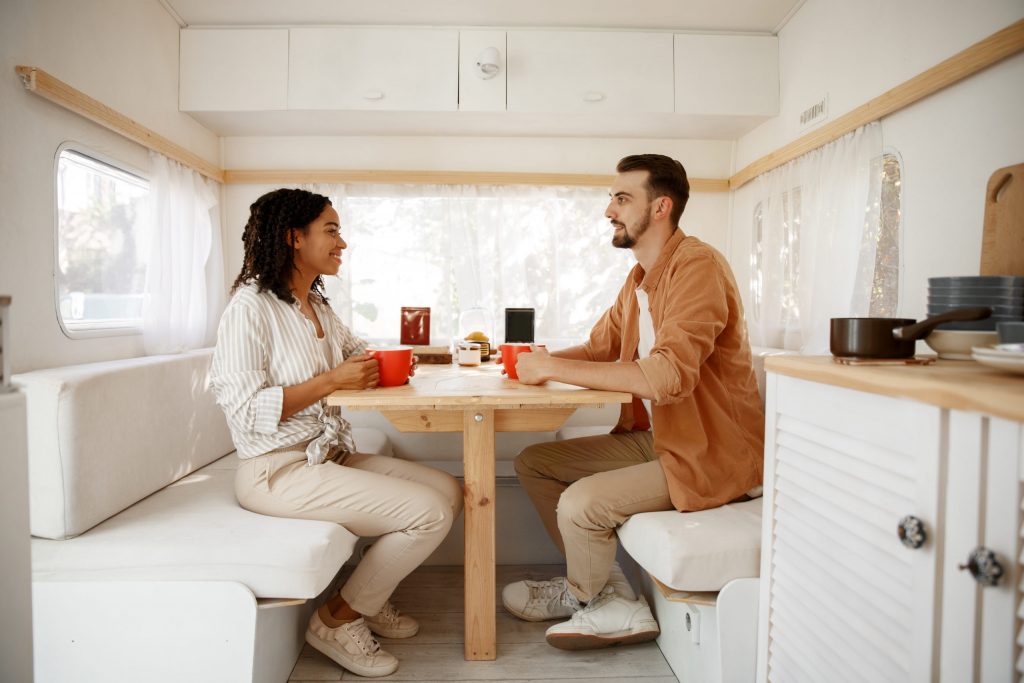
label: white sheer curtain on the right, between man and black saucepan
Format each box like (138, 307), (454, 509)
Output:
(749, 123), (883, 354)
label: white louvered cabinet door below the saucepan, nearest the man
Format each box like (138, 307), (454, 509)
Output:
(758, 374), (942, 683)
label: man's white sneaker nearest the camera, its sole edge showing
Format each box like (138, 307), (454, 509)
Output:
(545, 586), (660, 650)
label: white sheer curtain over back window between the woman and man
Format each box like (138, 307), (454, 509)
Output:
(305, 184), (634, 345)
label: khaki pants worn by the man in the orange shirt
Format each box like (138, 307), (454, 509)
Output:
(515, 432), (675, 601)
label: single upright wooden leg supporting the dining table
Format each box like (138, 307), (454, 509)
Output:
(462, 410), (497, 660)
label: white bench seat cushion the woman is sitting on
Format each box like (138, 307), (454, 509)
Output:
(32, 455), (356, 608)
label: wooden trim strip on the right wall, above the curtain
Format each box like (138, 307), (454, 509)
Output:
(729, 19), (1024, 189)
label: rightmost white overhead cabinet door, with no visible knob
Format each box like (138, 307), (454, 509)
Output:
(675, 35), (778, 117)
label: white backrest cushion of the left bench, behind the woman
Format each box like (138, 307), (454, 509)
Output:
(12, 349), (234, 539)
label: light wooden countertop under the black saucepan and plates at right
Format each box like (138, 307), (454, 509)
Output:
(765, 355), (1024, 422)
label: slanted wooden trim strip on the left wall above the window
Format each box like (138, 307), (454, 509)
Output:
(14, 66), (224, 182)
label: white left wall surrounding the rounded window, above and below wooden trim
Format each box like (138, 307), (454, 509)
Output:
(0, 0), (219, 372)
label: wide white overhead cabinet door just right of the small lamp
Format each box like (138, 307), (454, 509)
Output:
(508, 31), (673, 113)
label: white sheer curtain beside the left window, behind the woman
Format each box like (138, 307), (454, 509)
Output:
(142, 153), (224, 354)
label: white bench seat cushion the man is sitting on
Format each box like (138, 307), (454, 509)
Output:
(617, 498), (762, 591)
